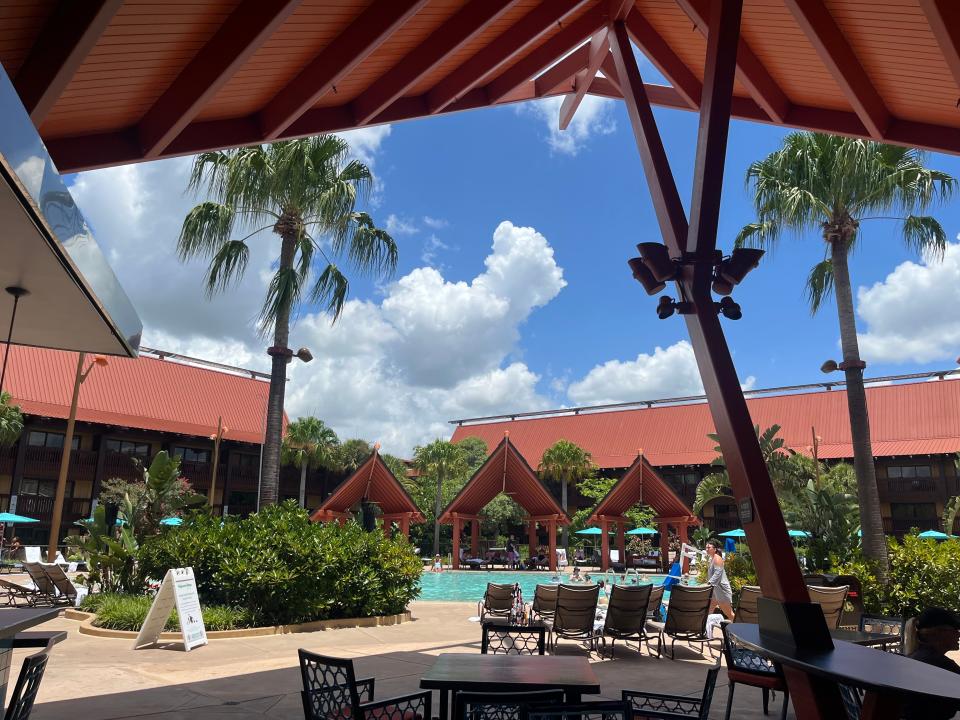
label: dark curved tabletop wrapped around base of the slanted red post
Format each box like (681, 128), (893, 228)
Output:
(727, 623), (960, 718)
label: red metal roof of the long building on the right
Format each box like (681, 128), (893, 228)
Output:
(453, 380), (960, 468)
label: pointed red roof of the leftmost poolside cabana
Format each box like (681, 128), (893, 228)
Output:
(310, 450), (424, 523)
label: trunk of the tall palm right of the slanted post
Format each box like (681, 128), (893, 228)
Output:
(830, 237), (889, 581)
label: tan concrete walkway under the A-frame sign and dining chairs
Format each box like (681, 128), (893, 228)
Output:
(15, 602), (793, 720)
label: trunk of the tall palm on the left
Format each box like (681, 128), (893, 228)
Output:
(258, 232), (296, 509)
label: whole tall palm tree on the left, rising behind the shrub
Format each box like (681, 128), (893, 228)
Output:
(177, 135), (397, 505)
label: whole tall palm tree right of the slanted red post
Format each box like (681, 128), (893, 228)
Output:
(736, 133), (957, 578)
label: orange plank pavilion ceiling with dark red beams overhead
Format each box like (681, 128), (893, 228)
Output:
(0, 0), (960, 172)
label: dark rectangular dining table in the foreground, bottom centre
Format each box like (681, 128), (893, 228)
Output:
(420, 653), (600, 720)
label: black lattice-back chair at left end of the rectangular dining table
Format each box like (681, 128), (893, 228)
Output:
(297, 648), (432, 720)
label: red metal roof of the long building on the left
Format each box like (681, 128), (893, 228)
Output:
(0, 345), (270, 445)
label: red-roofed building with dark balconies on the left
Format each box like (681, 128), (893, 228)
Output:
(0, 345), (312, 544)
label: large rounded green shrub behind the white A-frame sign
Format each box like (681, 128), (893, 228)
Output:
(140, 501), (423, 625)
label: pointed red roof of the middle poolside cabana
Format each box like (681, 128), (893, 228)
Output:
(440, 436), (570, 525)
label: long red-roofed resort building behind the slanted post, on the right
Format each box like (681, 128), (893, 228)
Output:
(452, 371), (960, 534)
